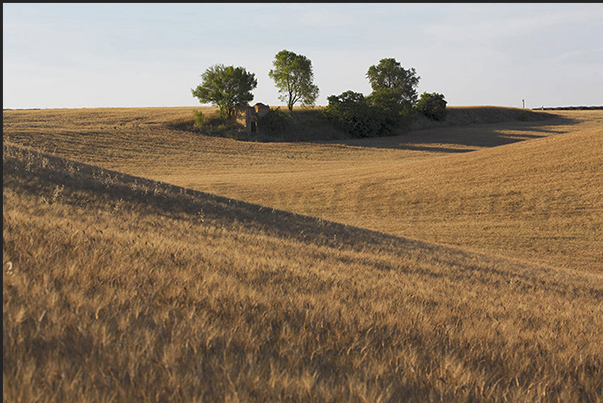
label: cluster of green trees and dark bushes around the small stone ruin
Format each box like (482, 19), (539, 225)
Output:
(192, 50), (446, 137)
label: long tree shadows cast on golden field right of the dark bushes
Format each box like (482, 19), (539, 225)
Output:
(319, 116), (579, 153)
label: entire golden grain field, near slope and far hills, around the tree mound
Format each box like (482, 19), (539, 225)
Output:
(3, 108), (603, 402)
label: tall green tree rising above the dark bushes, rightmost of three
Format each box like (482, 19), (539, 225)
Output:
(366, 58), (421, 106)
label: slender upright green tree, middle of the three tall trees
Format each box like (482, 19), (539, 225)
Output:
(268, 50), (318, 111)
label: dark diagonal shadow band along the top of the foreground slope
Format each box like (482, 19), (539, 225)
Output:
(2, 144), (420, 254)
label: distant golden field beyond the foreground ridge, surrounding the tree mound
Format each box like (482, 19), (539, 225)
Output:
(4, 107), (603, 273)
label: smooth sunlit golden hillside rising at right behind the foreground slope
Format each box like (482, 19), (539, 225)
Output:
(258, 109), (603, 273)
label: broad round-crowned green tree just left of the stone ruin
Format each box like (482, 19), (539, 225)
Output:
(191, 64), (258, 118)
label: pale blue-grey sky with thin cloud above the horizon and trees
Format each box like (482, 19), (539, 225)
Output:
(2, 3), (603, 109)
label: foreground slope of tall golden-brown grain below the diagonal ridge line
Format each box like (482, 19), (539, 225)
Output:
(3, 144), (603, 402)
